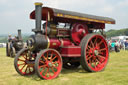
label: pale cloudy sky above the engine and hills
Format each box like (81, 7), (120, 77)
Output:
(0, 0), (128, 34)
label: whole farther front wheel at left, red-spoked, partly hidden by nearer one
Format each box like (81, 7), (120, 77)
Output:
(14, 48), (35, 75)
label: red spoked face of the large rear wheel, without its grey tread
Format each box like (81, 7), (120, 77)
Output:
(85, 35), (108, 71)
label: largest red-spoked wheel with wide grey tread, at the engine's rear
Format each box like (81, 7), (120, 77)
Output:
(81, 34), (109, 72)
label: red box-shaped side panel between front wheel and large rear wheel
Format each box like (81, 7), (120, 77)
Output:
(60, 46), (81, 57)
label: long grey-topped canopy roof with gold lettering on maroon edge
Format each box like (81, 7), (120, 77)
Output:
(30, 7), (115, 24)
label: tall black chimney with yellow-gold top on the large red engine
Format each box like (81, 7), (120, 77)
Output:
(35, 2), (43, 33)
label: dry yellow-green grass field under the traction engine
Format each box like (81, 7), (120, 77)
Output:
(0, 48), (128, 85)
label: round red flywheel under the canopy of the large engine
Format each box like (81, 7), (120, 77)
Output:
(71, 23), (88, 45)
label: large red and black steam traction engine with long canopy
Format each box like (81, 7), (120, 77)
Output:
(14, 3), (115, 79)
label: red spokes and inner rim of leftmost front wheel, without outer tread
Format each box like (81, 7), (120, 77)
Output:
(17, 51), (35, 75)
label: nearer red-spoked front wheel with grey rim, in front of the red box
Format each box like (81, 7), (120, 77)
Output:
(35, 49), (62, 80)
